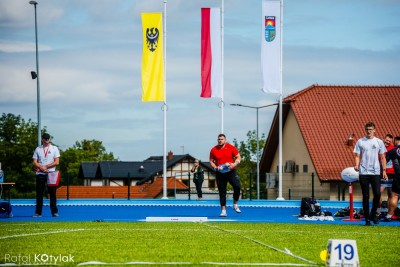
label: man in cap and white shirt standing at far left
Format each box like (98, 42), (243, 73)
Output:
(32, 133), (60, 217)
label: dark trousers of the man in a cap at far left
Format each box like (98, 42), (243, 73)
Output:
(36, 174), (58, 215)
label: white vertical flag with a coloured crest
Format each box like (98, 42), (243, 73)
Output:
(261, 0), (282, 93)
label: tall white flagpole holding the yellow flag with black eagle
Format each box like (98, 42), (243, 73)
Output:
(162, 0), (168, 199)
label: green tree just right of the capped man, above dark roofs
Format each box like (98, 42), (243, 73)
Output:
(60, 139), (116, 184)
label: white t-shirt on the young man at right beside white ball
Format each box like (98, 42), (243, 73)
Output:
(354, 137), (386, 175)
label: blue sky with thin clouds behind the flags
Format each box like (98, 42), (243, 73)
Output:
(0, 0), (400, 161)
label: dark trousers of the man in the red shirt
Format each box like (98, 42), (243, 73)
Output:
(216, 170), (240, 206)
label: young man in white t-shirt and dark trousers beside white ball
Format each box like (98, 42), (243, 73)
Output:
(353, 122), (388, 226)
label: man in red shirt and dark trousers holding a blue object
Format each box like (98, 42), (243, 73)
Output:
(210, 134), (241, 217)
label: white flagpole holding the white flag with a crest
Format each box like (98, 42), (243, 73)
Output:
(277, 0), (285, 200)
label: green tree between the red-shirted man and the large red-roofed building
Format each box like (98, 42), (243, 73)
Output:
(233, 130), (265, 198)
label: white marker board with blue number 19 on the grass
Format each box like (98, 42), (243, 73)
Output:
(325, 239), (360, 267)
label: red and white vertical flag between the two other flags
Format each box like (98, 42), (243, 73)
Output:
(200, 8), (222, 98)
